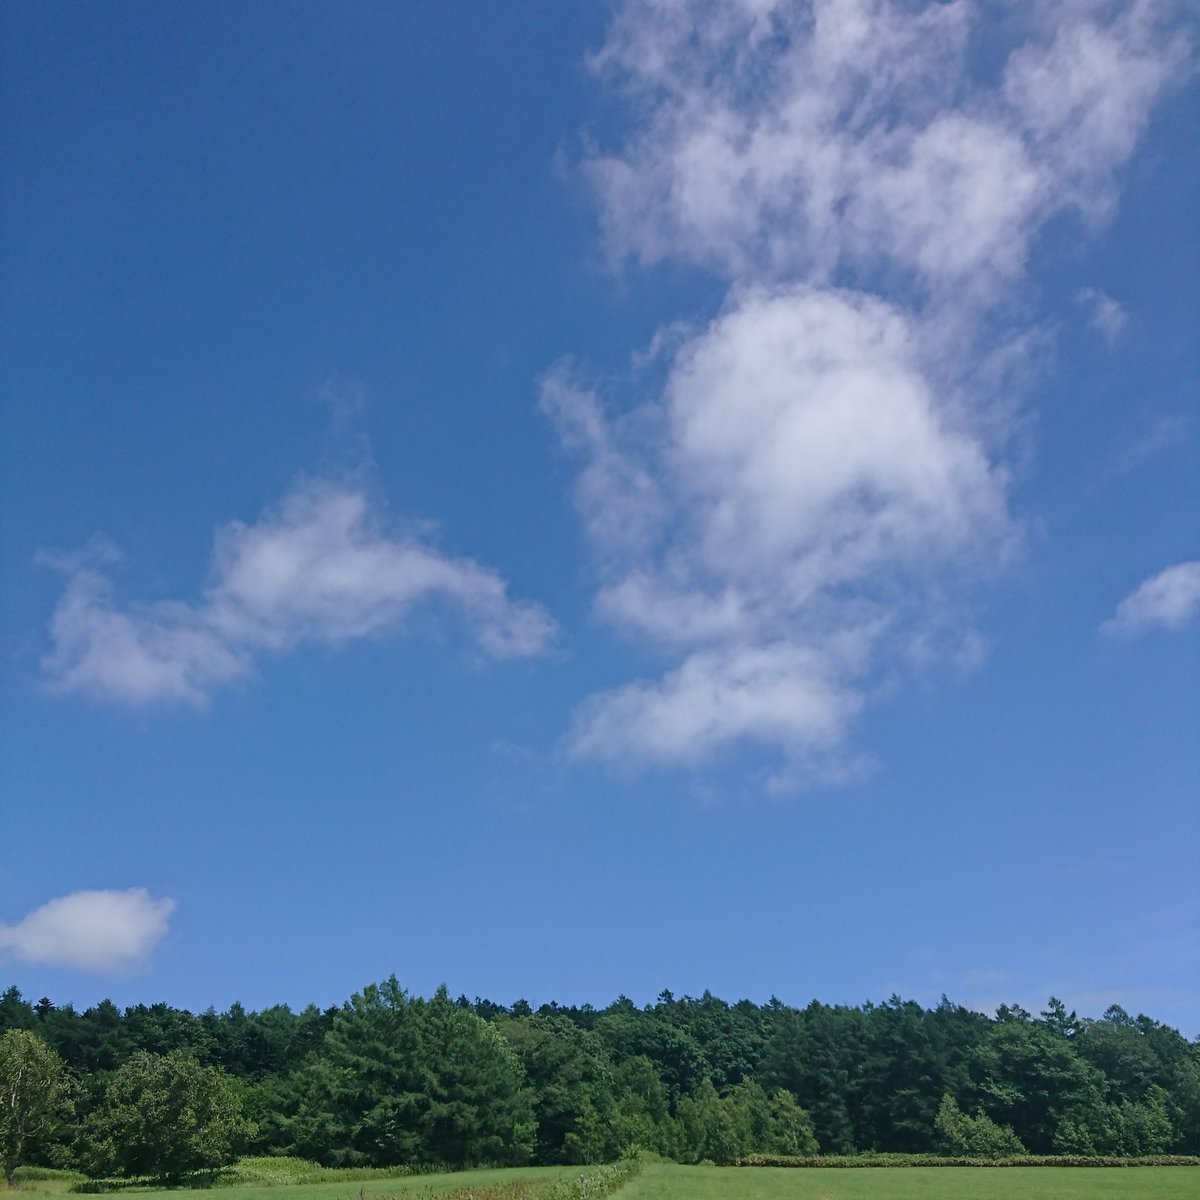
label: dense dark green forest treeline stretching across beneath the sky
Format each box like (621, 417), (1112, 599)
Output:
(0, 979), (1200, 1174)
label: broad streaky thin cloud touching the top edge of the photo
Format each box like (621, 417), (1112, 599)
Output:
(586, 0), (1186, 297)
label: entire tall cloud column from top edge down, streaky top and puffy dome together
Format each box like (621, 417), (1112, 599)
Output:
(552, 0), (1187, 778)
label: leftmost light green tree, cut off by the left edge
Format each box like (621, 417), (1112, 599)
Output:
(0, 1028), (71, 1188)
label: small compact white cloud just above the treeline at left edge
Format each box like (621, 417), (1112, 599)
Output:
(0, 888), (175, 971)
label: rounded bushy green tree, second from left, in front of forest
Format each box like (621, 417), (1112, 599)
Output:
(84, 1050), (254, 1180)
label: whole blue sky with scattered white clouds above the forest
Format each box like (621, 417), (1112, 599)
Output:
(0, 0), (1200, 1036)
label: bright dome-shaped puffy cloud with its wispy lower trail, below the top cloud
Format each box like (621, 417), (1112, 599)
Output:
(547, 286), (1013, 764)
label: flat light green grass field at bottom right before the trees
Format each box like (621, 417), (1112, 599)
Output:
(619, 1164), (1200, 1200)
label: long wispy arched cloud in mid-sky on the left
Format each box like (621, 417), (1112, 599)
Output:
(44, 480), (553, 706)
